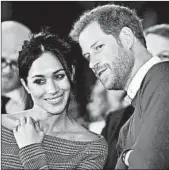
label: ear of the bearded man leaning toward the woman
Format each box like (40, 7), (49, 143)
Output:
(119, 27), (134, 49)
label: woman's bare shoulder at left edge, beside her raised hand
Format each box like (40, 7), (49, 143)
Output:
(1, 110), (28, 130)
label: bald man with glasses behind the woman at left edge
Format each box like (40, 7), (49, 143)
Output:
(1, 21), (31, 114)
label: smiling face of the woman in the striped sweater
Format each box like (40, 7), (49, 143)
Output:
(27, 53), (71, 114)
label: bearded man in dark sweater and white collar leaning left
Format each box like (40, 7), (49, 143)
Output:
(70, 4), (169, 169)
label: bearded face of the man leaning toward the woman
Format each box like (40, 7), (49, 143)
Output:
(79, 22), (134, 90)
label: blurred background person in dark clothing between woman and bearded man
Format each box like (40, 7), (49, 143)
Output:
(87, 80), (134, 170)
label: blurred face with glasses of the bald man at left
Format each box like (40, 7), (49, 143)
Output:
(1, 46), (21, 93)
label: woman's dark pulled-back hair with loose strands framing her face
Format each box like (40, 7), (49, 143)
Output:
(18, 28), (74, 86)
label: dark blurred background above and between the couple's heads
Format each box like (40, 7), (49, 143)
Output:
(1, 1), (169, 121)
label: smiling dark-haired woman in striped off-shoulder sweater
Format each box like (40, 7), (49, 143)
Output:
(1, 31), (107, 169)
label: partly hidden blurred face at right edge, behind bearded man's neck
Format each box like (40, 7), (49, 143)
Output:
(146, 34), (169, 61)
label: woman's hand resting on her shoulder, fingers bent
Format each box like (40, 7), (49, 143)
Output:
(13, 117), (44, 148)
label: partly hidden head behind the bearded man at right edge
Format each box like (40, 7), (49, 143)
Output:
(145, 24), (169, 61)
